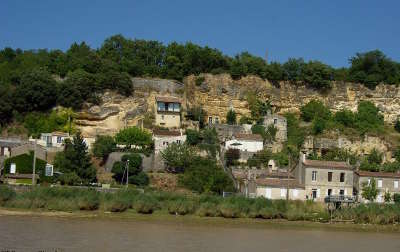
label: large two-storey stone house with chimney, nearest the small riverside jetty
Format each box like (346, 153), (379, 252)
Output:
(295, 154), (354, 201)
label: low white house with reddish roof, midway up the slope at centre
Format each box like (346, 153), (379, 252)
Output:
(225, 134), (264, 152)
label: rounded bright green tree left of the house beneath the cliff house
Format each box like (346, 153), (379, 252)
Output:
(115, 127), (153, 150)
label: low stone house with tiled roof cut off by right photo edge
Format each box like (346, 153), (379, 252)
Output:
(354, 171), (400, 202)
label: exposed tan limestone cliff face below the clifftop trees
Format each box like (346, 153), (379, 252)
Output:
(77, 74), (400, 140)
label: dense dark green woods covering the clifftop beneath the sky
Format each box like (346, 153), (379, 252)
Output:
(0, 35), (400, 128)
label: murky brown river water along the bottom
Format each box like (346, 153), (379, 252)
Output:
(0, 216), (400, 252)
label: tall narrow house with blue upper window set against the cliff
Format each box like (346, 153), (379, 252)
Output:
(155, 96), (181, 128)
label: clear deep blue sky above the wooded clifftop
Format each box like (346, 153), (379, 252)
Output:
(0, 0), (400, 67)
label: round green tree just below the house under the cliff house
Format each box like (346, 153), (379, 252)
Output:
(161, 143), (195, 173)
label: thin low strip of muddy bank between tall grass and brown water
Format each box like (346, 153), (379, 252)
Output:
(0, 207), (400, 233)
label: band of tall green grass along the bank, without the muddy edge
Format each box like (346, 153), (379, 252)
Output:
(0, 186), (400, 225)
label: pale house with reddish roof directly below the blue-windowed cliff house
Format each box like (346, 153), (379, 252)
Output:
(153, 130), (186, 154)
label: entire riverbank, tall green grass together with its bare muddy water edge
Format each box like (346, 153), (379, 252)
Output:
(0, 186), (400, 231)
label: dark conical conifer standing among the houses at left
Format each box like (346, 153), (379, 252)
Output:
(54, 131), (96, 183)
